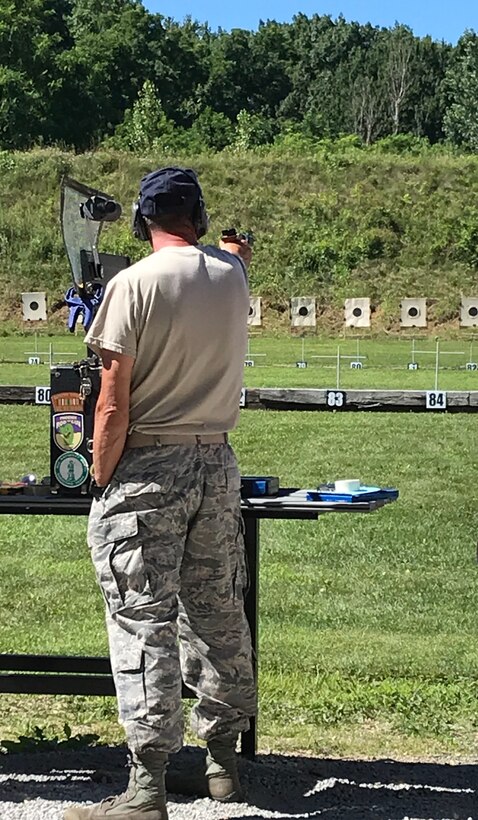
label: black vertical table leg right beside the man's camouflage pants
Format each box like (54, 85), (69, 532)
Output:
(241, 516), (259, 759)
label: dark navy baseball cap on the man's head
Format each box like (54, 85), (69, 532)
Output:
(139, 167), (202, 217)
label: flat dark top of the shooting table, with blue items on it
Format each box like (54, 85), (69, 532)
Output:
(0, 487), (389, 519)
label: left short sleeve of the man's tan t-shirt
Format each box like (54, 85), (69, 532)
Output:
(85, 276), (137, 358)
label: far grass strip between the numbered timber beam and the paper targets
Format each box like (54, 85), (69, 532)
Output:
(0, 332), (478, 390)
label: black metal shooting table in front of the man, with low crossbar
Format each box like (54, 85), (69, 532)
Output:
(0, 487), (388, 757)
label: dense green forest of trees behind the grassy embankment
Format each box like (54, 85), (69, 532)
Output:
(0, 0), (478, 151)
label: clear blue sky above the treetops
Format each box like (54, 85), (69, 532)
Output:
(143, 0), (478, 43)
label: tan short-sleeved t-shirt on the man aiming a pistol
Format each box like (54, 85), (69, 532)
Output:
(85, 245), (249, 435)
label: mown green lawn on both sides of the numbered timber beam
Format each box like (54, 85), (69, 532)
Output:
(0, 337), (478, 757)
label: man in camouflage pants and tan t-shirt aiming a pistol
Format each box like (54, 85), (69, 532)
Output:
(64, 167), (255, 820)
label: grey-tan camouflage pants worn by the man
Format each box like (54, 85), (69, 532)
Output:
(88, 444), (255, 752)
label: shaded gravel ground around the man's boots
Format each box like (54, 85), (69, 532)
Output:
(0, 747), (478, 820)
